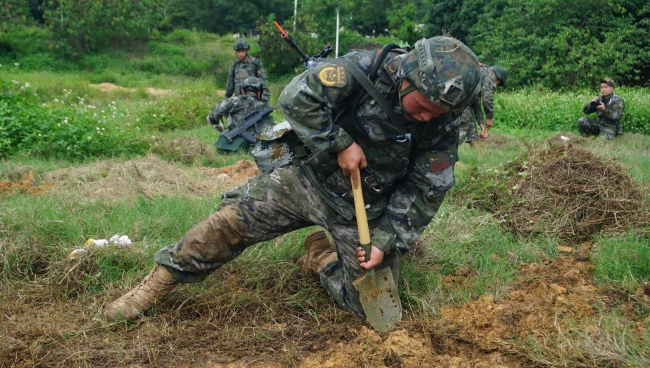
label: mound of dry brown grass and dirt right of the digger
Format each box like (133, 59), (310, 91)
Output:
(491, 137), (650, 244)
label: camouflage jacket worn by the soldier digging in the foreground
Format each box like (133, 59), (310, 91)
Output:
(279, 50), (459, 255)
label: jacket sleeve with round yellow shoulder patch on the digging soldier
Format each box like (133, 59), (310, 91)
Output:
(278, 63), (356, 152)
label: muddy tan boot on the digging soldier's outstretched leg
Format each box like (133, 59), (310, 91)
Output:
(104, 264), (178, 322)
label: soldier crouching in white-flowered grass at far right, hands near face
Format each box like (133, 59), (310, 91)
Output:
(578, 78), (625, 139)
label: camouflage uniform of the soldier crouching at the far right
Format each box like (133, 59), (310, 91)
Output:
(578, 93), (625, 139)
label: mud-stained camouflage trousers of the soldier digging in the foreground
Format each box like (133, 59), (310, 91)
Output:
(155, 165), (399, 317)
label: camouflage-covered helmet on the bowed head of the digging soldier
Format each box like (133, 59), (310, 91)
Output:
(395, 36), (481, 112)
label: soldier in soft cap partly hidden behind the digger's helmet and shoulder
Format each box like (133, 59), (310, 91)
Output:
(458, 64), (508, 145)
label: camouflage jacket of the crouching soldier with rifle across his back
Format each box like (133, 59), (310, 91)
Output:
(208, 93), (273, 130)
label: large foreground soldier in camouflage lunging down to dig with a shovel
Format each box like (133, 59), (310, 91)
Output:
(105, 36), (481, 330)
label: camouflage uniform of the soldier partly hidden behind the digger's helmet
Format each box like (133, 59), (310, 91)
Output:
(458, 64), (497, 144)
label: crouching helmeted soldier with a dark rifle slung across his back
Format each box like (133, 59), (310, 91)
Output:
(208, 77), (274, 152)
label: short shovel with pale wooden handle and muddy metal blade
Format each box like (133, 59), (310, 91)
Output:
(350, 169), (402, 332)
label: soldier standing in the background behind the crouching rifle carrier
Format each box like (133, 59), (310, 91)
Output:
(226, 40), (271, 101)
